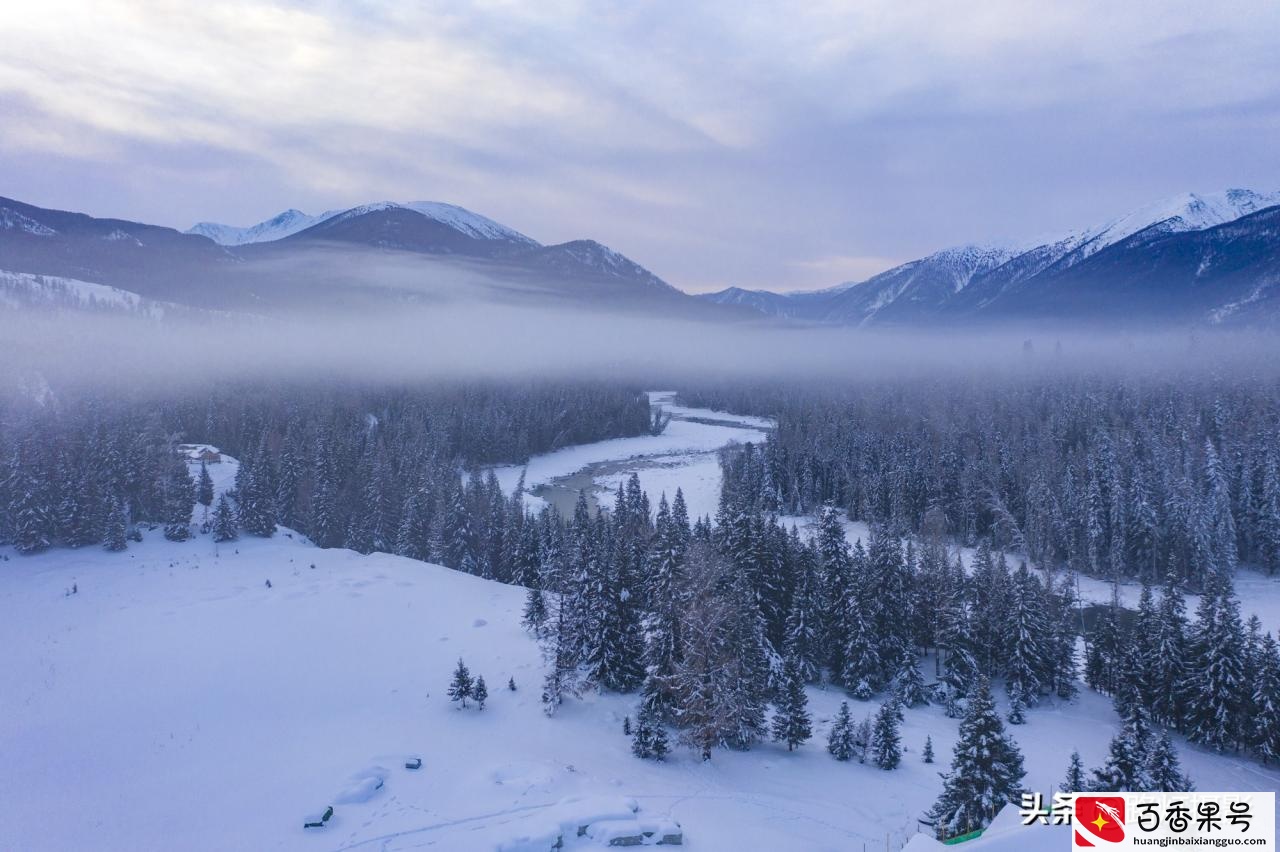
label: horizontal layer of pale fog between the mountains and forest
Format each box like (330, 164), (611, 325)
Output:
(0, 295), (1280, 399)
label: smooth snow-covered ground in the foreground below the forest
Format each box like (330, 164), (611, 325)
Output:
(0, 531), (1280, 851)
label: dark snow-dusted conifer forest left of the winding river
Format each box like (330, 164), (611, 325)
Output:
(0, 383), (652, 557)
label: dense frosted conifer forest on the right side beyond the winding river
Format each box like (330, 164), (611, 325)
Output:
(687, 372), (1280, 587)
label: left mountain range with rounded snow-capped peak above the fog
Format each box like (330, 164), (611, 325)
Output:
(0, 198), (727, 319)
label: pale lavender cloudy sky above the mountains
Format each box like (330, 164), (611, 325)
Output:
(0, 0), (1280, 292)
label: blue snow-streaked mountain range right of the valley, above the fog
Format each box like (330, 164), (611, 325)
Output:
(701, 189), (1280, 326)
